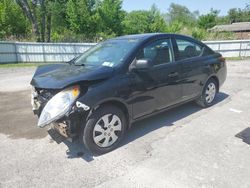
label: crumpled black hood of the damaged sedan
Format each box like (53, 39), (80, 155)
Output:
(30, 64), (113, 89)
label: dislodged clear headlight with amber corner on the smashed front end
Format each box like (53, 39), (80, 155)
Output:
(38, 86), (80, 127)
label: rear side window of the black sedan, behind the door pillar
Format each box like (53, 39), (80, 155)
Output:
(176, 39), (202, 60)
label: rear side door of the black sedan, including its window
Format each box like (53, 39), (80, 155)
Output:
(173, 37), (209, 101)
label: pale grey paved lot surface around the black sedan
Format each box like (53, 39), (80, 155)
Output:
(0, 60), (250, 188)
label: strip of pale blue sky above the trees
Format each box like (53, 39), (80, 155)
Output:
(123, 0), (250, 16)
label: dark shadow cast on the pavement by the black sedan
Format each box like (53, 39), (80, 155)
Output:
(63, 92), (229, 162)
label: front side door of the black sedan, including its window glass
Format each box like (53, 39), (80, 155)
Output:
(130, 38), (181, 119)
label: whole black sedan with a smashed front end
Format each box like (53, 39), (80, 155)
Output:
(31, 33), (227, 155)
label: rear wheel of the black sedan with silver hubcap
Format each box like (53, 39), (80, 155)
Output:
(196, 78), (218, 108)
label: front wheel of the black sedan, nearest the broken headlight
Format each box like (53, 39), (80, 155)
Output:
(80, 106), (127, 155)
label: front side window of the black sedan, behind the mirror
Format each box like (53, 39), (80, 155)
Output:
(136, 39), (173, 65)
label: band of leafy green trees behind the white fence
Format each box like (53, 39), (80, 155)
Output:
(0, 0), (250, 42)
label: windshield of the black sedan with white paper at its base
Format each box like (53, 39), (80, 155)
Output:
(75, 39), (138, 67)
